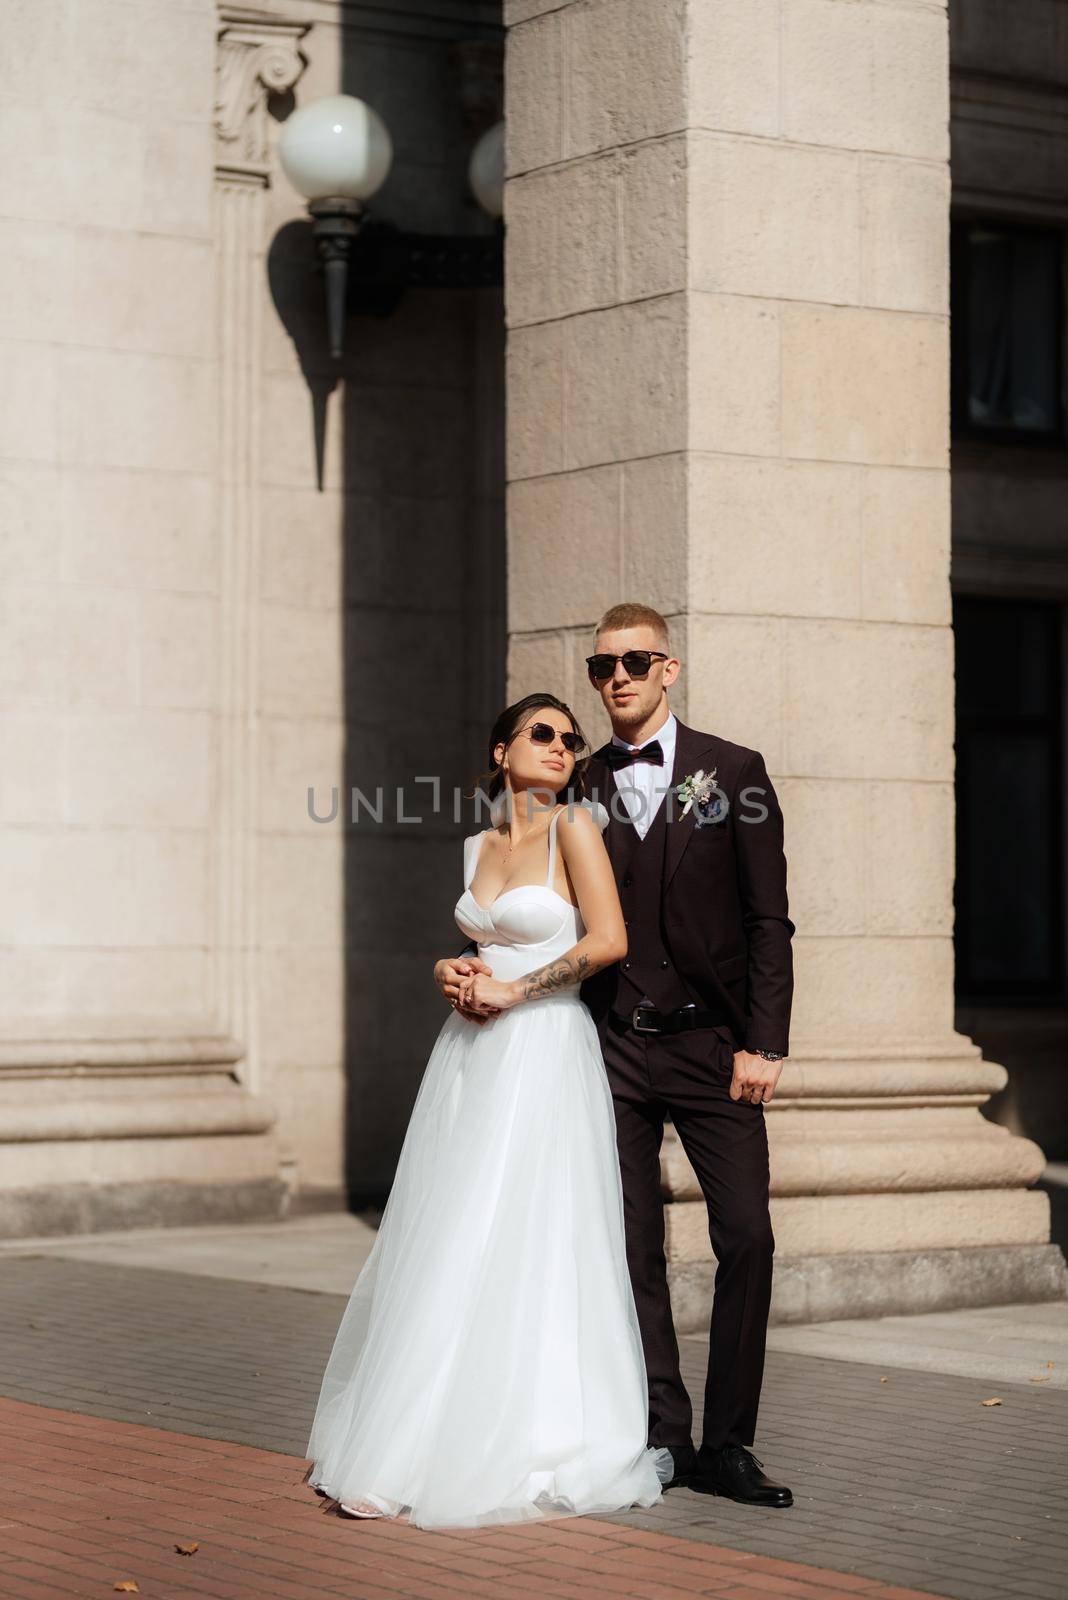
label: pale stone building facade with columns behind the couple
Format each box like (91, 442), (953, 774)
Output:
(0, 0), (1065, 1323)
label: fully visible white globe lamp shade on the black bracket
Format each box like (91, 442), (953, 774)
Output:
(278, 94), (393, 200)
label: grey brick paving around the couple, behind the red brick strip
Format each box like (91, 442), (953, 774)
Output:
(0, 1256), (1068, 1600)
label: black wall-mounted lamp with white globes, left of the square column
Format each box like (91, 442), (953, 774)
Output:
(278, 94), (504, 360)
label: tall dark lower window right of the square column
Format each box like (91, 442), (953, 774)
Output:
(953, 597), (1065, 1002)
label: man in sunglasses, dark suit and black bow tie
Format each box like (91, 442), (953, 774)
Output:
(435, 605), (795, 1506)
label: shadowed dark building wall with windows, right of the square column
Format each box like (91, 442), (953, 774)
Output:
(950, 3), (1068, 1162)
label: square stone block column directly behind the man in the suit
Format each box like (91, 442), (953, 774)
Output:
(505, 0), (1063, 1326)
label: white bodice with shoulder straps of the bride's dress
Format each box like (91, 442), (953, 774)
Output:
(454, 800), (608, 982)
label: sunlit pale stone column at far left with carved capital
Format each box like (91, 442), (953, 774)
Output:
(0, 0), (309, 1237)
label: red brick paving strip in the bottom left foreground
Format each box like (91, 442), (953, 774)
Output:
(0, 1400), (946, 1600)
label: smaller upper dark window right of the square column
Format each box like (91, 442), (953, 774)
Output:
(951, 222), (1063, 438)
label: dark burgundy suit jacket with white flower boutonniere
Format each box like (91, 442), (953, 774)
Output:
(580, 722), (795, 1054)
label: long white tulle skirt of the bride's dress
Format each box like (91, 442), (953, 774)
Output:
(307, 994), (671, 1528)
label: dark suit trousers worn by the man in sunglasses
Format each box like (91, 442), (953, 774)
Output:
(603, 1027), (775, 1450)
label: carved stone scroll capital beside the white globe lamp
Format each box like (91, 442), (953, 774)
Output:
(214, 5), (303, 173)
